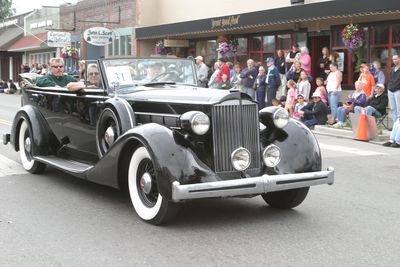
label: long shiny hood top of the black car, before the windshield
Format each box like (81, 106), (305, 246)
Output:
(123, 86), (239, 104)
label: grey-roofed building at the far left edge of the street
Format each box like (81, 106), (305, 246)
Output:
(0, 14), (27, 81)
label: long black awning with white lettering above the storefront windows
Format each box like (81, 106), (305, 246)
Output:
(136, 0), (400, 39)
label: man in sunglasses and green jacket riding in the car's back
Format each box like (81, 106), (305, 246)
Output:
(36, 58), (76, 87)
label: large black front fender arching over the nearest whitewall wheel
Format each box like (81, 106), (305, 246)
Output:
(87, 123), (218, 200)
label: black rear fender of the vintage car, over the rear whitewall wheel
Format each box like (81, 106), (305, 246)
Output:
(10, 105), (61, 156)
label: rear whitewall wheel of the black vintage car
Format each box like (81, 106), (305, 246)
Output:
(18, 119), (46, 174)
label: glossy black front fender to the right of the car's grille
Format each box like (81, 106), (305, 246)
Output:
(260, 119), (322, 174)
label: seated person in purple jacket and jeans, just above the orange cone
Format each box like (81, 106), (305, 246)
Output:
(333, 81), (367, 128)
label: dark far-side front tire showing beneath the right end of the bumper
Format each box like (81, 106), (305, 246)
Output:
(261, 187), (310, 209)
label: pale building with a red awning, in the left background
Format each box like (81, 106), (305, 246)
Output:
(8, 7), (60, 66)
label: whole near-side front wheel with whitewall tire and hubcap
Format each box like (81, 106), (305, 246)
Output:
(128, 147), (178, 225)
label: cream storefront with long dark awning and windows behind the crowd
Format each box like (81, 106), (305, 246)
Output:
(135, 0), (400, 86)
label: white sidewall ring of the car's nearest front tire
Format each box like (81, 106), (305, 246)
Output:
(128, 147), (163, 221)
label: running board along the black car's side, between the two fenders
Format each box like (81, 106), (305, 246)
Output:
(34, 156), (94, 174)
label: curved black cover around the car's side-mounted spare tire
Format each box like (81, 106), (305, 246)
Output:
(96, 97), (136, 157)
